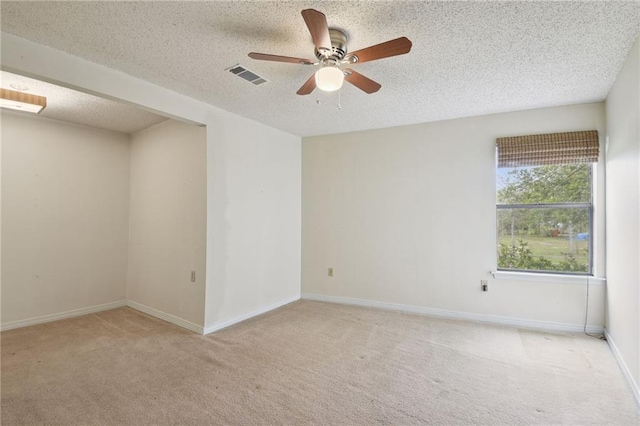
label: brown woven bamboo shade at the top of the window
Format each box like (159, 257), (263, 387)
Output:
(496, 130), (600, 167)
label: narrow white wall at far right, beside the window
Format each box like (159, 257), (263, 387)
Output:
(606, 35), (640, 401)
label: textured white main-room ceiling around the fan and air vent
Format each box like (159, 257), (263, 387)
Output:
(0, 1), (640, 136)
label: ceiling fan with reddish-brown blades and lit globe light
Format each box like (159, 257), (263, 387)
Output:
(249, 9), (411, 95)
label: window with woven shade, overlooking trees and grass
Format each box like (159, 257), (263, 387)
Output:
(496, 131), (599, 275)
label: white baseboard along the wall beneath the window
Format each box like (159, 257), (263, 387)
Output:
(302, 293), (604, 334)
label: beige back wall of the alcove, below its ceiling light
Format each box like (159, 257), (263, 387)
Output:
(2, 111), (129, 326)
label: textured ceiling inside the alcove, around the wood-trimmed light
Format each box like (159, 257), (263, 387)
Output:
(0, 71), (166, 133)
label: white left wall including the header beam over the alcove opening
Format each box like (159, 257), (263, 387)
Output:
(0, 33), (301, 330)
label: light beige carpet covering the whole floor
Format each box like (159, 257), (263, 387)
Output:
(1, 301), (640, 426)
